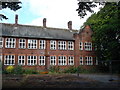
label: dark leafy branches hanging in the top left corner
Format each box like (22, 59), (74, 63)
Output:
(0, 1), (21, 20)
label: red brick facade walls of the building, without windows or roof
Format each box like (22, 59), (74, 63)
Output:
(2, 17), (96, 70)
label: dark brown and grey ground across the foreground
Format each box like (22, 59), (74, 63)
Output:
(3, 74), (120, 89)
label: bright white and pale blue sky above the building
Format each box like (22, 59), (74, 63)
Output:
(0, 0), (99, 30)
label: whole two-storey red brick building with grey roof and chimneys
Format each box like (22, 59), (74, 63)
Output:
(0, 15), (97, 70)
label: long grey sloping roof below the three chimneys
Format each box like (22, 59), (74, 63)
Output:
(0, 23), (78, 40)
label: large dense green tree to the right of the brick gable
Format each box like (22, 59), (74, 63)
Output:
(84, 2), (120, 60)
